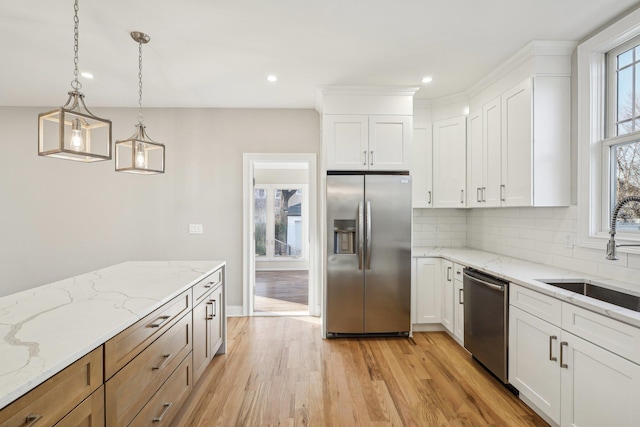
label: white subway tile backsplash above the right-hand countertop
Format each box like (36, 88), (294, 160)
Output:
(413, 206), (640, 287)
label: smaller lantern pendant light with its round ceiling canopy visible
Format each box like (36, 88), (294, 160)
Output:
(116, 31), (164, 175)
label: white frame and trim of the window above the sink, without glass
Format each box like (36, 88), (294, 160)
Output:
(577, 9), (640, 254)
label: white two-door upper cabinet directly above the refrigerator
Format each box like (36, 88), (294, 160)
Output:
(318, 86), (418, 171)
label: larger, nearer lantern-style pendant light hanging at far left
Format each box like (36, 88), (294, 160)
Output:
(38, 0), (111, 162)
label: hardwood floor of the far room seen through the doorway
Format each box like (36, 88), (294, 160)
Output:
(253, 270), (309, 313)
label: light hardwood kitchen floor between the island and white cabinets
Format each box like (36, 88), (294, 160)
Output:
(175, 317), (547, 427)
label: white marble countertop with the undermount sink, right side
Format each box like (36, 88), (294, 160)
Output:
(412, 247), (640, 328)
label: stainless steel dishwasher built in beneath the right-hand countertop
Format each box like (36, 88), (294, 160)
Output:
(463, 268), (509, 384)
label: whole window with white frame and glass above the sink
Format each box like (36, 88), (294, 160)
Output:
(576, 9), (640, 253)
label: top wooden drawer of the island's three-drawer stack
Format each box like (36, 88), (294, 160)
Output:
(104, 289), (191, 379)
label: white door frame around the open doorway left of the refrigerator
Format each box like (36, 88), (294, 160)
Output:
(242, 153), (322, 316)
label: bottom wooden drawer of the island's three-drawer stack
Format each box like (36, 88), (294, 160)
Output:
(129, 355), (192, 427)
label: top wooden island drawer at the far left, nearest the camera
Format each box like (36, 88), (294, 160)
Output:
(0, 347), (102, 427)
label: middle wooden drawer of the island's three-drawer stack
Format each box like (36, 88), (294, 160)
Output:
(106, 314), (191, 426)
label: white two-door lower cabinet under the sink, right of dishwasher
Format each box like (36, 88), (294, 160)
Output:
(509, 284), (640, 427)
